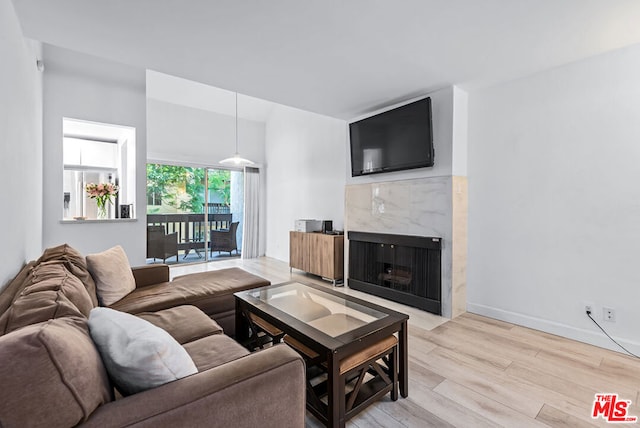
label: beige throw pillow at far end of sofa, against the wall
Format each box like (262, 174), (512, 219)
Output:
(87, 245), (136, 306)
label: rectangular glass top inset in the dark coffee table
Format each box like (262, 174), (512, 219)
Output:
(247, 282), (388, 337)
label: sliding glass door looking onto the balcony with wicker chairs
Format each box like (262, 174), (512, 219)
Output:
(147, 164), (244, 263)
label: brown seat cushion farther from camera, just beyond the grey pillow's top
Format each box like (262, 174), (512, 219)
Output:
(137, 305), (222, 345)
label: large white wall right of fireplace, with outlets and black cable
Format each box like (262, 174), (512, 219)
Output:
(468, 46), (640, 353)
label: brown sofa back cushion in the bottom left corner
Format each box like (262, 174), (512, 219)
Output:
(0, 317), (112, 427)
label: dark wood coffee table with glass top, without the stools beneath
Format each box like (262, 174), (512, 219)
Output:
(234, 282), (409, 427)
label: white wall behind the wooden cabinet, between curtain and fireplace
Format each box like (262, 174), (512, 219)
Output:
(266, 105), (347, 261)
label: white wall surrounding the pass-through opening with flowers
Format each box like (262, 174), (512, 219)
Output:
(43, 45), (146, 265)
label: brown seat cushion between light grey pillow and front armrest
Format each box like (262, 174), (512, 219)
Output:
(184, 334), (249, 372)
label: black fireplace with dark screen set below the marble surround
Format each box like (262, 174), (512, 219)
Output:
(348, 232), (442, 315)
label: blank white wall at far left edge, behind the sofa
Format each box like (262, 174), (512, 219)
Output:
(0, 0), (42, 288)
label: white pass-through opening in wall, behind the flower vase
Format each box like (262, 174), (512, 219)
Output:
(62, 118), (136, 220)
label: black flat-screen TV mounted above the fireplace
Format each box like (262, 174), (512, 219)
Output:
(349, 98), (433, 177)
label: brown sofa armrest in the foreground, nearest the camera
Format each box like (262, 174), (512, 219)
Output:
(85, 344), (306, 428)
